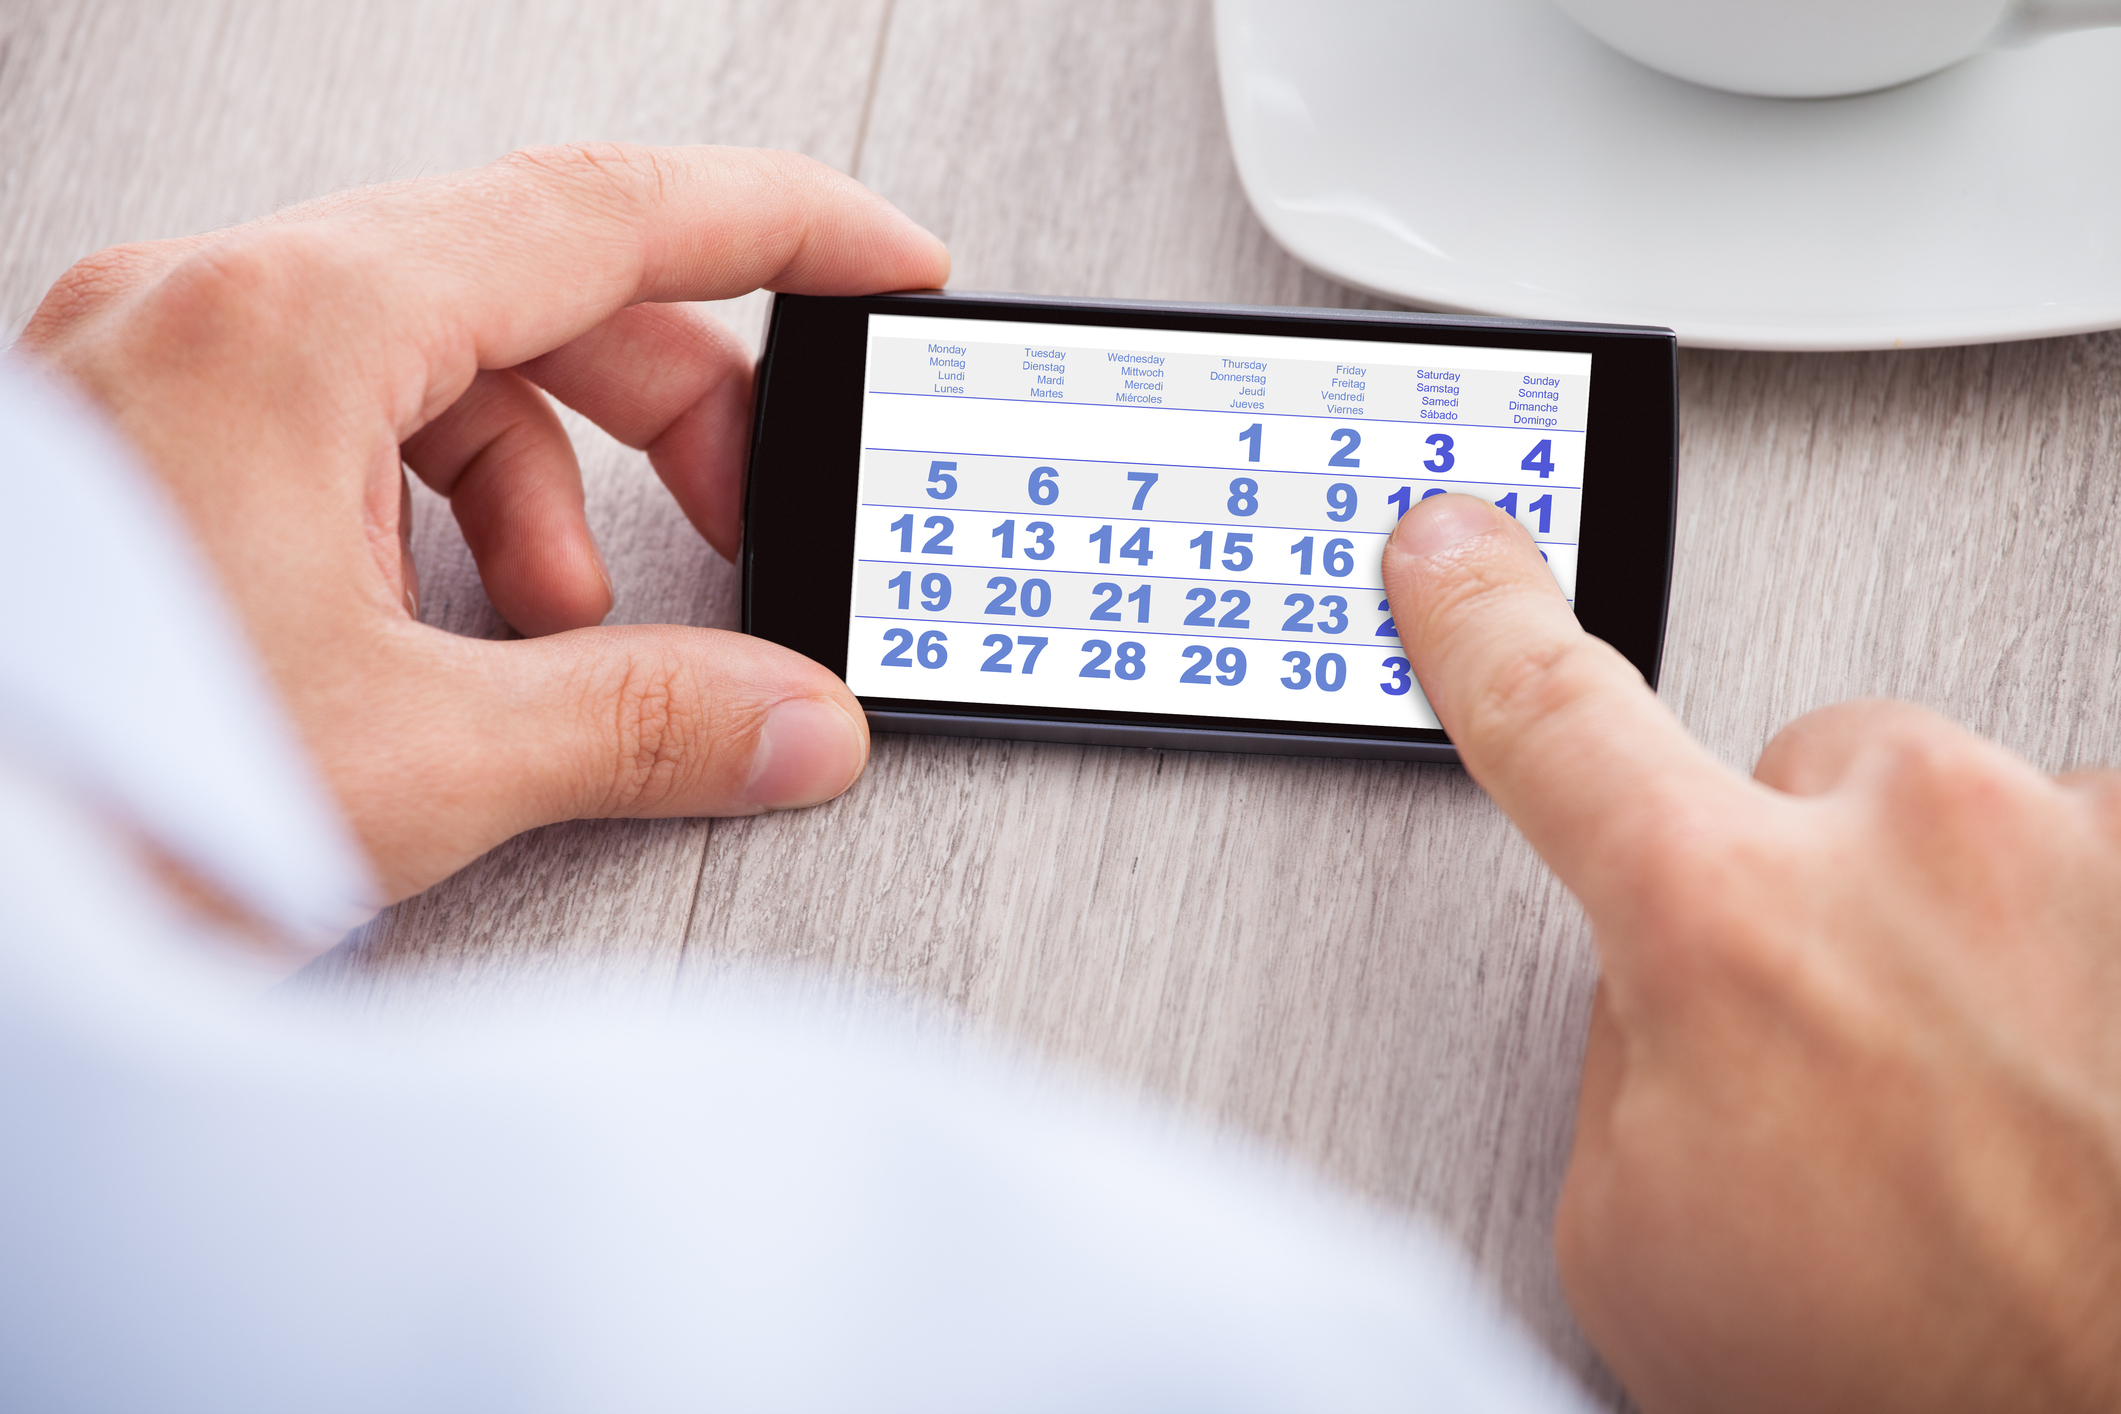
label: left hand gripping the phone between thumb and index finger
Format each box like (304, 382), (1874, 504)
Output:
(23, 146), (950, 899)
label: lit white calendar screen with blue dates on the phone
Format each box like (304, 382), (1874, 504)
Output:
(846, 314), (1591, 727)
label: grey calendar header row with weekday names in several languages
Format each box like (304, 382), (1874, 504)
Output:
(867, 337), (1591, 432)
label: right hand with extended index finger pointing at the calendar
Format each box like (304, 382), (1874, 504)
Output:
(1385, 496), (2121, 1414)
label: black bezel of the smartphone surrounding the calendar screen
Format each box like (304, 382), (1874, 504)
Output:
(742, 290), (1678, 761)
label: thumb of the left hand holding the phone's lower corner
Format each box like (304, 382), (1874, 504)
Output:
(345, 625), (870, 897)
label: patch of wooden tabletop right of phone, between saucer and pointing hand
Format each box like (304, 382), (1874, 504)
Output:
(1663, 333), (2121, 772)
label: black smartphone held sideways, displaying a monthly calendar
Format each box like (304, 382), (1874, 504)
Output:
(742, 293), (1678, 761)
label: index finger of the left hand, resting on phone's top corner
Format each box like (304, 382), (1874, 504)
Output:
(184, 144), (950, 432)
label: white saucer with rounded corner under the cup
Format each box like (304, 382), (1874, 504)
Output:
(1215, 0), (2121, 350)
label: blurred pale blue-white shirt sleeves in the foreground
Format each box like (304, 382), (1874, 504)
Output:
(0, 363), (1589, 1414)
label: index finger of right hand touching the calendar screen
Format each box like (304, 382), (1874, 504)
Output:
(1385, 496), (1754, 916)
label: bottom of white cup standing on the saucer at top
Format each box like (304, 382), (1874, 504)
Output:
(1555, 0), (2121, 98)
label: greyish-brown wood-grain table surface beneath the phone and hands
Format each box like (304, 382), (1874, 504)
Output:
(0, 0), (2121, 1395)
